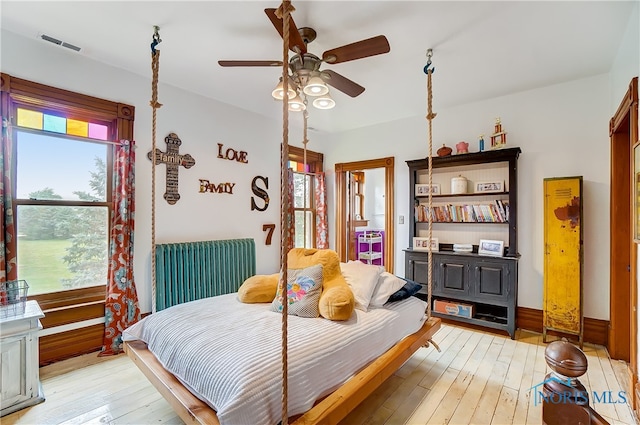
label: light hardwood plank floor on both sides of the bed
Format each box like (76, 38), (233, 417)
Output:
(0, 325), (636, 425)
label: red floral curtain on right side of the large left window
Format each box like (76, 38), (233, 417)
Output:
(100, 140), (140, 356)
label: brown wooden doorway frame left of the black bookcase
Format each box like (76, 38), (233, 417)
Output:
(335, 157), (395, 272)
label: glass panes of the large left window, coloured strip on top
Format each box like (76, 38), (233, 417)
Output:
(13, 108), (113, 295)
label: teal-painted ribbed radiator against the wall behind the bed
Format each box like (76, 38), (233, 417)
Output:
(156, 239), (256, 311)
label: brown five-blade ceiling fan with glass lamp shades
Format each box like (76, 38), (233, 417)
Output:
(218, 9), (390, 102)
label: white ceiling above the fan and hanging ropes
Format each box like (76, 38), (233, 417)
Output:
(1, 0), (637, 132)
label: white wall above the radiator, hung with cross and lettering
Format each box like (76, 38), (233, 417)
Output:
(1, 31), (302, 312)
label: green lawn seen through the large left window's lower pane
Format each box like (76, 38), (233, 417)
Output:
(18, 238), (72, 295)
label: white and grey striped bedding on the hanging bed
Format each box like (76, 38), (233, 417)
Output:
(124, 294), (425, 425)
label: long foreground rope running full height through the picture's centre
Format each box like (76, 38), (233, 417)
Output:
(276, 0), (295, 425)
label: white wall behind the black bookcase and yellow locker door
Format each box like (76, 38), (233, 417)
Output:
(323, 73), (610, 319)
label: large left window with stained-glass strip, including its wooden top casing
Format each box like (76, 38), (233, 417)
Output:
(2, 74), (133, 296)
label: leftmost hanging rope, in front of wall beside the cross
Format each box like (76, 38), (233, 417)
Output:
(149, 25), (162, 313)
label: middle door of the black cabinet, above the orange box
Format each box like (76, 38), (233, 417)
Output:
(434, 256), (471, 299)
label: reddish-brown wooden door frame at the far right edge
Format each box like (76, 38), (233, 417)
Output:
(607, 77), (639, 411)
